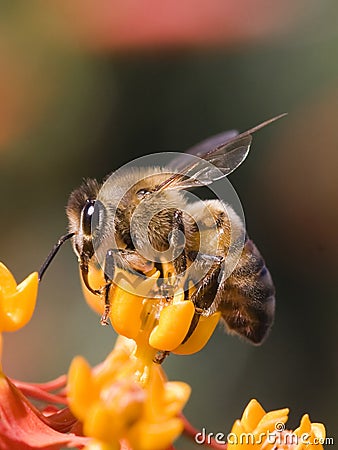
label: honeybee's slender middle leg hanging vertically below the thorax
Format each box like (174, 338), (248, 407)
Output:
(169, 210), (187, 282)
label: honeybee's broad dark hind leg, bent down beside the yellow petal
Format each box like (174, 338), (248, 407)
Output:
(182, 254), (224, 344)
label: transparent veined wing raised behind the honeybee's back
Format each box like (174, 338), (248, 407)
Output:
(157, 114), (286, 191)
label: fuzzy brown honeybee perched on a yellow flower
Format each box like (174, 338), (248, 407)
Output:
(39, 114), (284, 363)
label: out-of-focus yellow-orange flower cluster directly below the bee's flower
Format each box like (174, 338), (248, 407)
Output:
(68, 338), (190, 450)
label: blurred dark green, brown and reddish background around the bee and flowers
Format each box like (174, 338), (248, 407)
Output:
(0, 0), (338, 449)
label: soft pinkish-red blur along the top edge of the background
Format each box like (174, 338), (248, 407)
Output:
(54, 0), (307, 50)
